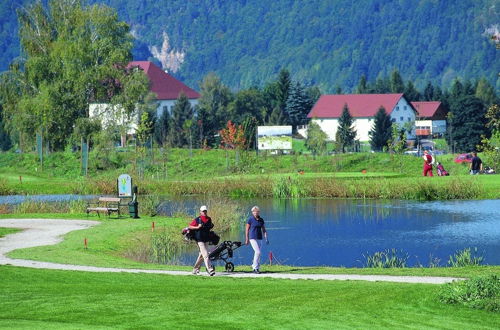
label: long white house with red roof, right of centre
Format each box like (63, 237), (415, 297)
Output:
(307, 94), (417, 141)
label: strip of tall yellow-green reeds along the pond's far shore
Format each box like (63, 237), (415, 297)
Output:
(0, 176), (483, 200)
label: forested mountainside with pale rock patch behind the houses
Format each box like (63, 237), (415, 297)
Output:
(0, 0), (500, 92)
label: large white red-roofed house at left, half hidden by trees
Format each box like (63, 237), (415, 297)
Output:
(89, 61), (200, 138)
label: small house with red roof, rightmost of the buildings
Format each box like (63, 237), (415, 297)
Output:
(411, 101), (446, 138)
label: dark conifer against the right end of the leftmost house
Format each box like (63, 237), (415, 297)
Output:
(169, 93), (193, 147)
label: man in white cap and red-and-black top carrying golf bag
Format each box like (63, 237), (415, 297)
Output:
(189, 205), (215, 276)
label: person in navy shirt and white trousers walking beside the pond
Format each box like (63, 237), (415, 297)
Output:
(245, 206), (269, 274)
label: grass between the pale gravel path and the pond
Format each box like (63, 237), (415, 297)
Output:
(0, 214), (500, 277)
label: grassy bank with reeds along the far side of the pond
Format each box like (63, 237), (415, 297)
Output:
(0, 149), (500, 200)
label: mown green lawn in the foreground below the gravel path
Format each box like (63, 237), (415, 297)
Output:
(0, 266), (500, 329)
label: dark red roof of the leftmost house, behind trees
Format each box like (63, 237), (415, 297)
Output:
(128, 61), (200, 100)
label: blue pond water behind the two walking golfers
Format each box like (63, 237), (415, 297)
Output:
(167, 199), (500, 267)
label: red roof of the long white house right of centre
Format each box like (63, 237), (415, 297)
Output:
(307, 94), (403, 118)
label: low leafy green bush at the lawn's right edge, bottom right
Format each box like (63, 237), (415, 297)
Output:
(439, 275), (500, 313)
